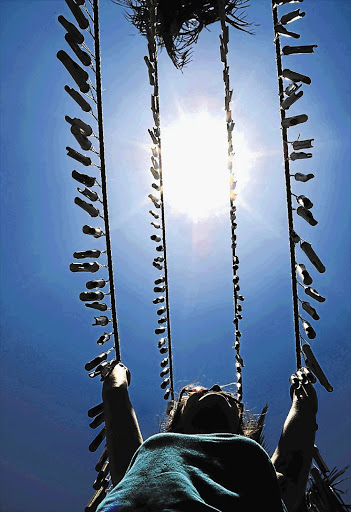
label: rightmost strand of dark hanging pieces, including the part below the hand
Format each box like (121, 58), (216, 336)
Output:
(272, 0), (347, 512)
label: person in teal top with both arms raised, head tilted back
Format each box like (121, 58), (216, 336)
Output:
(97, 363), (318, 512)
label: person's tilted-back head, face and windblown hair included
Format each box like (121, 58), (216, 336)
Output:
(162, 384), (267, 441)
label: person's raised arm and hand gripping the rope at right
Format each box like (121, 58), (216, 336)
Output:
(272, 368), (318, 512)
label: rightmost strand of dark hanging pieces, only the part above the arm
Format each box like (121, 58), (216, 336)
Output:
(272, 0), (332, 391)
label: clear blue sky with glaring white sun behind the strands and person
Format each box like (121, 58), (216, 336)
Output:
(0, 0), (351, 512)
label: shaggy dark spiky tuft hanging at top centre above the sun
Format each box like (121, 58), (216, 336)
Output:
(115, 0), (253, 69)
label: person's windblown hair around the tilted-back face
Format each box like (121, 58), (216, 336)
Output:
(160, 384), (268, 444)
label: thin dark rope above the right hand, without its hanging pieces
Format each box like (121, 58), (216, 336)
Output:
(272, 0), (301, 369)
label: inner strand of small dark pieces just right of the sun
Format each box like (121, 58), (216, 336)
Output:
(218, 0), (244, 401)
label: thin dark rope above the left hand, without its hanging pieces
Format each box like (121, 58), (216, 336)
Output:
(93, 0), (121, 361)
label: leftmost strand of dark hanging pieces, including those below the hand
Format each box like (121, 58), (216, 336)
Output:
(57, 0), (121, 511)
